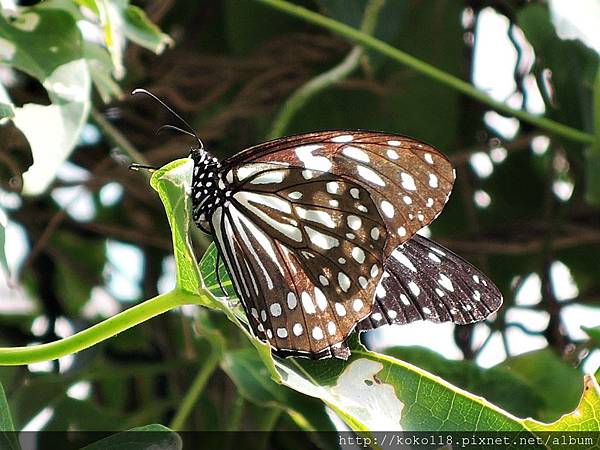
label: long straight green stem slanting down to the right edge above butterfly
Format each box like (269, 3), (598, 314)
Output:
(256, 0), (595, 144)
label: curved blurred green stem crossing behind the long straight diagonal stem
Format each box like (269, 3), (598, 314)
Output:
(269, 0), (384, 139)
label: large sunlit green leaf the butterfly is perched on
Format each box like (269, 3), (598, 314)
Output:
(152, 160), (600, 433)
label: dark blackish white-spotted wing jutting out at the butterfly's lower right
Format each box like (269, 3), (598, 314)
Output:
(358, 235), (502, 330)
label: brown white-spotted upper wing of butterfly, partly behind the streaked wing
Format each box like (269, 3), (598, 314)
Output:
(224, 131), (455, 256)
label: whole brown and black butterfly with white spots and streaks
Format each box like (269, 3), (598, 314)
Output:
(135, 92), (502, 359)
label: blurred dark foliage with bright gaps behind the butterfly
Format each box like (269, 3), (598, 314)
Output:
(0, 0), (600, 446)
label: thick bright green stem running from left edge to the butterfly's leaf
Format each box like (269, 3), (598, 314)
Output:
(0, 290), (203, 366)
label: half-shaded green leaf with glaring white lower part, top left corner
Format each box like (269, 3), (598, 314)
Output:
(0, 6), (91, 195)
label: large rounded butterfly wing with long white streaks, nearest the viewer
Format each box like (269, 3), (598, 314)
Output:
(212, 163), (386, 357)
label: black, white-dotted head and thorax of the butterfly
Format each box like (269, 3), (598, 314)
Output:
(190, 148), (231, 233)
